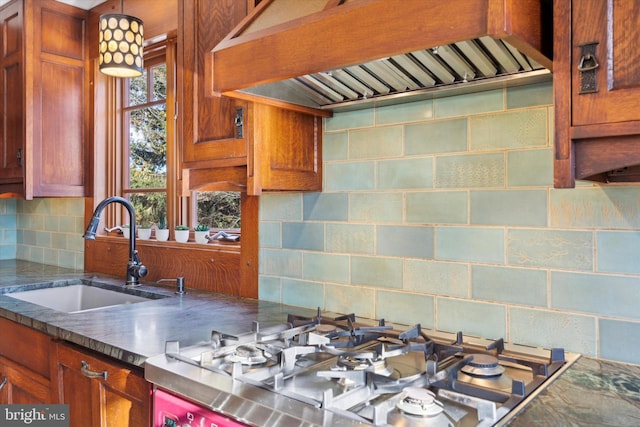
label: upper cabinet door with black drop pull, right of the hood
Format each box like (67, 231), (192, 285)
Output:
(571, 0), (640, 126)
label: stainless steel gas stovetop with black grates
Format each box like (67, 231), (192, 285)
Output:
(145, 310), (579, 427)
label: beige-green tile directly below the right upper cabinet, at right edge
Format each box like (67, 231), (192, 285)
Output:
(549, 186), (640, 229)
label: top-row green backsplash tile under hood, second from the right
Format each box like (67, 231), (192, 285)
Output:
(435, 89), (504, 119)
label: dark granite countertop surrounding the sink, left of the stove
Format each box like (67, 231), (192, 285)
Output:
(0, 260), (315, 366)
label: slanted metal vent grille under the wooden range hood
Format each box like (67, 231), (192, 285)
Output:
(241, 36), (551, 110)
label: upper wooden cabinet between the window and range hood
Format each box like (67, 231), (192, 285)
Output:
(178, 0), (330, 195)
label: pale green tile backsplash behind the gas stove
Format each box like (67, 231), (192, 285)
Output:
(259, 83), (640, 364)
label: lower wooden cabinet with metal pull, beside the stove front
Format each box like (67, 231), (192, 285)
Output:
(57, 344), (151, 427)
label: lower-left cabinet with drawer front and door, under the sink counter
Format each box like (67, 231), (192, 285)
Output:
(0, 319), (57, 404)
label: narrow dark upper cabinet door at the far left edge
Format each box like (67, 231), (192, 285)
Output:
(0, 1), (25, 183)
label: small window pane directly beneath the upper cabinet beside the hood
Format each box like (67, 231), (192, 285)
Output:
(197, 191), (240, 229)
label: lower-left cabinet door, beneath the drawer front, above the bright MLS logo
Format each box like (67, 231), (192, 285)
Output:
(0, 358), (54, 404)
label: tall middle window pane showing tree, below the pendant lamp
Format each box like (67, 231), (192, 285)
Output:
(129, 105), (167, 188)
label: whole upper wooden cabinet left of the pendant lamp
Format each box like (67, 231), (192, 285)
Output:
(0, 0), (90, 199)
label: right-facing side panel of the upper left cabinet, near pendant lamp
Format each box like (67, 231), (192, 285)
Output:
(25, 2), (89, 199)
